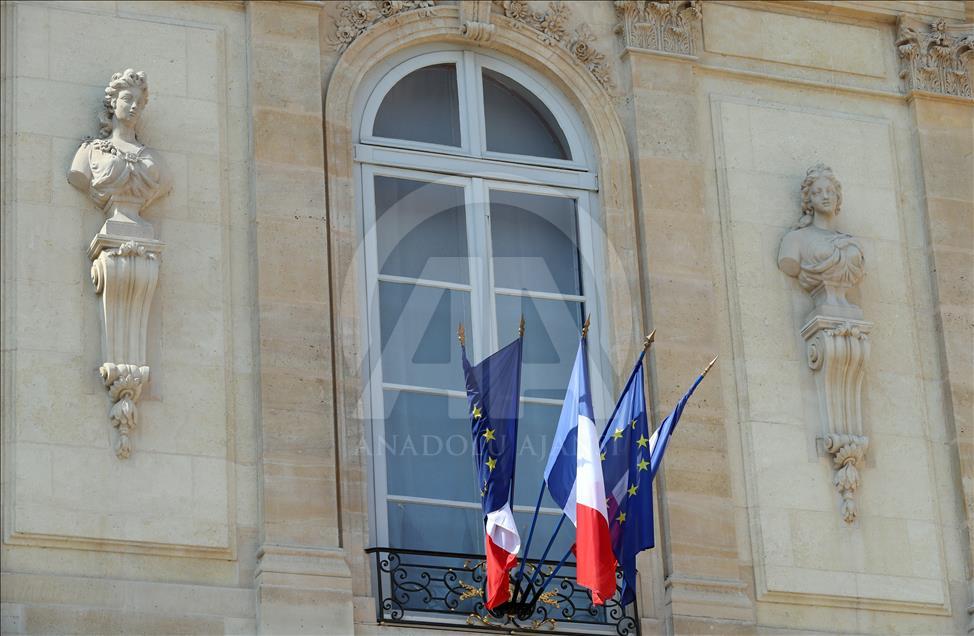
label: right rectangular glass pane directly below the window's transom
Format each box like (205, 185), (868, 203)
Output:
(490, 190), (582, 295)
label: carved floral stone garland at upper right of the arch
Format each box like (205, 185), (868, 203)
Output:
(494, 0), (613, 90)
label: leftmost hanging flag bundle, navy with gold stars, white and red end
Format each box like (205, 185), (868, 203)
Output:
(460, 332), (521, 609)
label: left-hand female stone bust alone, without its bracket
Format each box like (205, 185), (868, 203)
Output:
(68, 69), (171, 238)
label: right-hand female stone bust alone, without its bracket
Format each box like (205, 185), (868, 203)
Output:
(778, 164), (865, 318)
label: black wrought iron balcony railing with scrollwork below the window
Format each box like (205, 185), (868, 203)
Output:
(366, 548), (640, 636)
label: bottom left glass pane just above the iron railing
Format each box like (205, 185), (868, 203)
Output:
(388, 501), (482, 556)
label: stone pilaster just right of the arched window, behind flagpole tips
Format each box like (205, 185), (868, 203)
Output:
(617, 26), (754, 633)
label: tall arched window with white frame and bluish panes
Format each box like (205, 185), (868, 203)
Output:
(355, 51), (604, 556)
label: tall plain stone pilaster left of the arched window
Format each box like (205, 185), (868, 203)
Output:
(247, 2), (353, 634)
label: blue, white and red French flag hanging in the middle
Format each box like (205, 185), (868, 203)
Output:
(545, 335), (616, 605)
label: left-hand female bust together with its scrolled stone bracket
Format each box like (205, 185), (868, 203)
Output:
(68, 69), (171, 459)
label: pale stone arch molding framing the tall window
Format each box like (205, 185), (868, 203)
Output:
(325, 1), (644, 595)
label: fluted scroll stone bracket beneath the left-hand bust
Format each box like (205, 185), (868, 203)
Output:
(88, 234), (165, 459)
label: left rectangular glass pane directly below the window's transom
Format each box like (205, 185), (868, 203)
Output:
(375, 175), (469, 283)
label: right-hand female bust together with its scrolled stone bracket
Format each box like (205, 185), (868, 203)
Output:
(778, 164), (872, 523)
